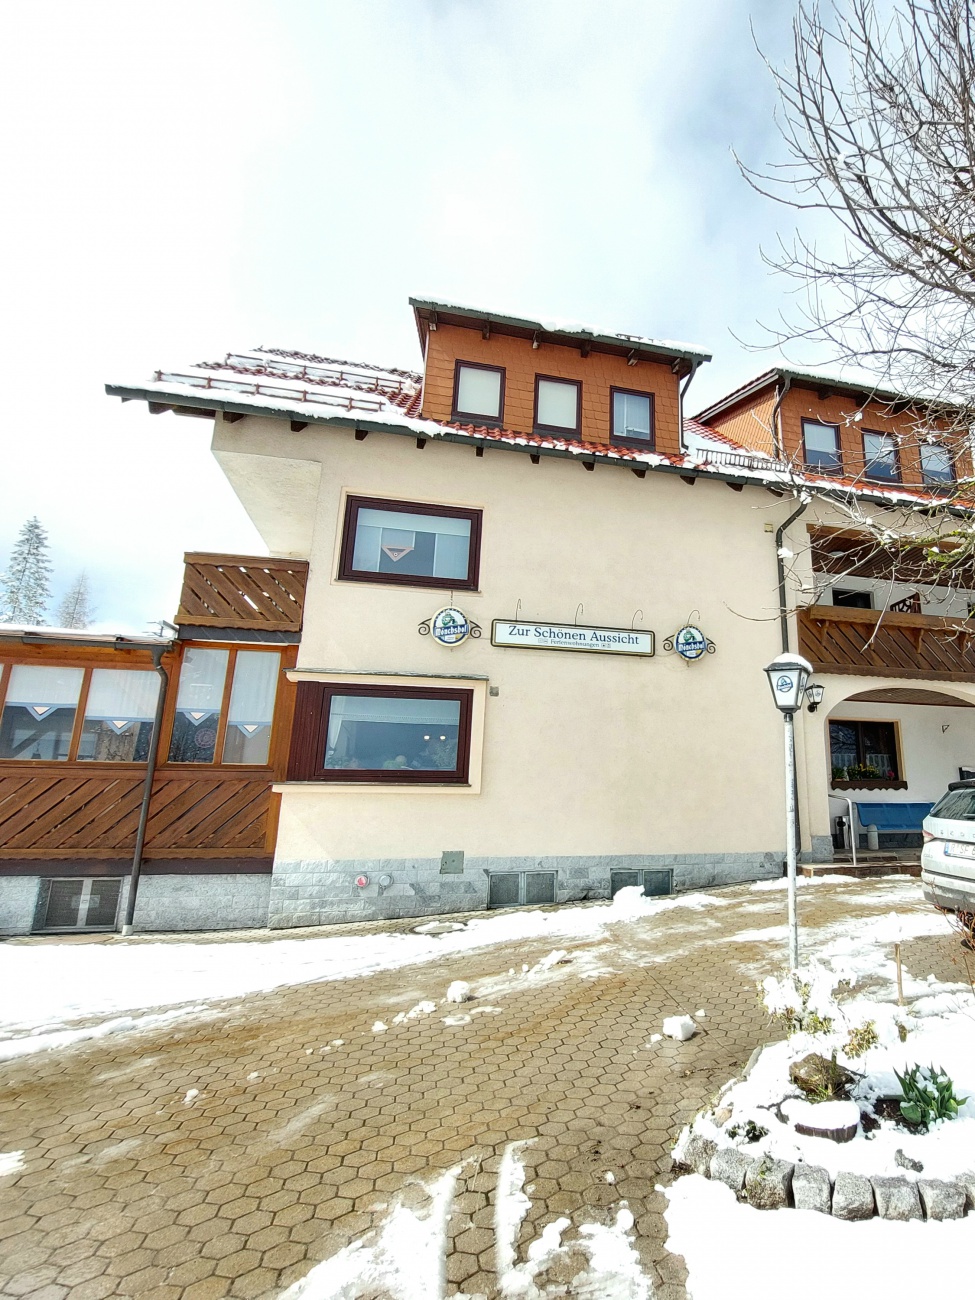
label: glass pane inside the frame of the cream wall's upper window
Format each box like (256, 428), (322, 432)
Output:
(352, 508), (471, 581)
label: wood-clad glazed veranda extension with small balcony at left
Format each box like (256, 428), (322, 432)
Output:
(0, 554), (307, 933)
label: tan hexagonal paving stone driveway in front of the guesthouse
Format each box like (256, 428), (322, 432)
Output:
(0, 880), (965, 1300)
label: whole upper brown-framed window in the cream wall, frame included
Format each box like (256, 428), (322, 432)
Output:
(338, 497), (481, 592)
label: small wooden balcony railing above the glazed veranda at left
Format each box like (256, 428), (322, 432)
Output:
(176, 551), (308, 632)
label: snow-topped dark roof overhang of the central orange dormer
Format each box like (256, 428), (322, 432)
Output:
(410, 298), (711, 377)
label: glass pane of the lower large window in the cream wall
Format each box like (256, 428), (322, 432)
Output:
(324, 696), (460, 772)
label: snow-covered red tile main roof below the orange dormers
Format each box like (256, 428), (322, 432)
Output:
(107, 347), (972, 506)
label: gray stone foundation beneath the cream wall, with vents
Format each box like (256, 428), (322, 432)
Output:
(268, 852), (783, 930)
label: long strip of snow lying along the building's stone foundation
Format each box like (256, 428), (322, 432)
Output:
(0, 888), (731, 1060)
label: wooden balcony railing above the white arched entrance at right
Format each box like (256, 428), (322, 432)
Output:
(798, 605), (975, 681)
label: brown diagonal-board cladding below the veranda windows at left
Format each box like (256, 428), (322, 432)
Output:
(0, 763), (276, 865)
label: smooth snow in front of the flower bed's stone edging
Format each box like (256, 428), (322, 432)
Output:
(666, 1174), (975, 1300)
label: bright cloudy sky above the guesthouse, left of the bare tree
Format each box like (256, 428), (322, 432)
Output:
(0, 0), (811, 629)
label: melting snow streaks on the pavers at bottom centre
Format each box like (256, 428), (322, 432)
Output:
(280, 1141), (650, 1300)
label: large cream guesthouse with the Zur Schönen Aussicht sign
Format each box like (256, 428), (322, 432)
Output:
(0, 300), (975, 927)
